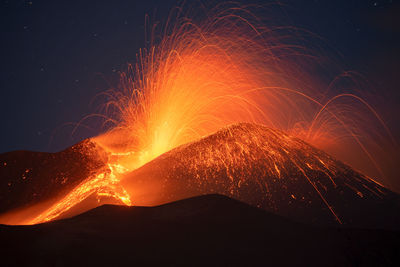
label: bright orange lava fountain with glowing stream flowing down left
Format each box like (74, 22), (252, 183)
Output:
(0, 6), (391, 224)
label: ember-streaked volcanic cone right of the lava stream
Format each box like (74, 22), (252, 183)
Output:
(122, 123), (400, 228)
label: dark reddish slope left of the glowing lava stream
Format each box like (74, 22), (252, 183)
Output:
(0, 139), (104, 214)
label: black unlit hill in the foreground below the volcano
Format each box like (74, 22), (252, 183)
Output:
(0, 195), (400, 266)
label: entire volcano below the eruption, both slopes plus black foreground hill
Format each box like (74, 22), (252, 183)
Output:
(0, 123), (400, 266)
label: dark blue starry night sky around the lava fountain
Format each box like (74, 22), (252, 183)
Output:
(0, 0), (400, 153)
